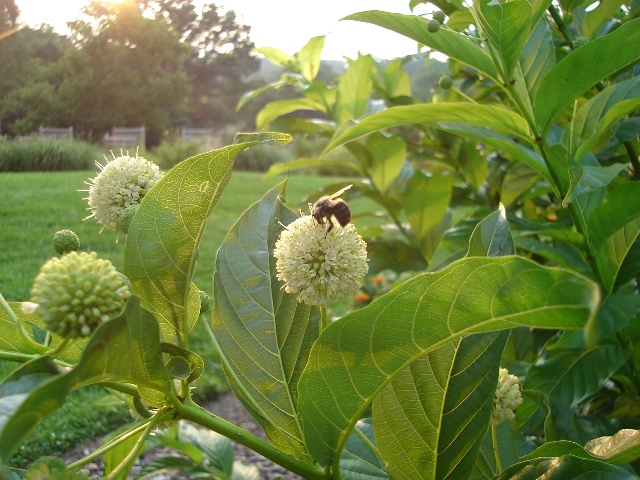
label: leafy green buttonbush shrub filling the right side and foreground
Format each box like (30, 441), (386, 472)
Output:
(0, 0), (640, 480)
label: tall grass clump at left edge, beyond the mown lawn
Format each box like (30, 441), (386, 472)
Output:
(0, 139), (101, 172)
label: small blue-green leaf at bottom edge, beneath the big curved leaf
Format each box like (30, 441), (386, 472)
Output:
(340, 418), (389, 480)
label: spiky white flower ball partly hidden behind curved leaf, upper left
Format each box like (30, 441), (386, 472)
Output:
(85, 154), (164, 232)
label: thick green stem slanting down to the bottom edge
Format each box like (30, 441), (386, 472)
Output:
(175, 401), (330, 480)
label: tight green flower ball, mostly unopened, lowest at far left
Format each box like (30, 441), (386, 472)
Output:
(31, 252), (131, 338)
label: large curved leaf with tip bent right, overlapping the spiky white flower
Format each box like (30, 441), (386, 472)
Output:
(124, 133), (291, 343)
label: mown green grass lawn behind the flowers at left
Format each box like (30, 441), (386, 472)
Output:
(0, 171), (337, 465)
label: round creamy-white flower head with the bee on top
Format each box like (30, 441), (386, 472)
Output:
(274, 215), (369, 305)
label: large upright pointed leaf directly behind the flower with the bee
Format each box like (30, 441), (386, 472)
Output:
(213, 183), (320, 458)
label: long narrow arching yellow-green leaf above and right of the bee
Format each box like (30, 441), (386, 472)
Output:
(324, 103), (530, 153)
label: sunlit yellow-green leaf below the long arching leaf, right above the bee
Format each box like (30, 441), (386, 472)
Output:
(366, 133), (407, 192)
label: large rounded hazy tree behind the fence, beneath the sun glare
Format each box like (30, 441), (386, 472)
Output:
(69, 1), (189, 145)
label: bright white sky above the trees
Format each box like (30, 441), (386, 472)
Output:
(16, 0), (426, 60)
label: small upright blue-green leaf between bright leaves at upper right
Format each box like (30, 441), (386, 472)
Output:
(520, 16), (556, 92)
